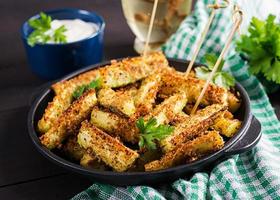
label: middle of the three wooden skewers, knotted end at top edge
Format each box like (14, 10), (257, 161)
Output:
(185, 0), (229, 77)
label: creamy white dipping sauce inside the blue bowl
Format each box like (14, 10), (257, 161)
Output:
(47, 19), (98, 44)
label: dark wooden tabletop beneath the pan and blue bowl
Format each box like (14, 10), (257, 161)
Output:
(0, 0), (280, 200)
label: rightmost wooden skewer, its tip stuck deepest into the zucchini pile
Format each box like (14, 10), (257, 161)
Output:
(191, 5), (242, 114)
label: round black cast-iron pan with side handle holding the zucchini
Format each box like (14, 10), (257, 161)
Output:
(28, 59), (261, 186)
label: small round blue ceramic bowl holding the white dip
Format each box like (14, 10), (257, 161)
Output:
(21, 9), (105, 79)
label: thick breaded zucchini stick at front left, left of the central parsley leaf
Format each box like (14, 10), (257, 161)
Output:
(78, 121), (139, 172)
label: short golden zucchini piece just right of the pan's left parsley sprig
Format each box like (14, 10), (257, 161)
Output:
(97, 88), (136, 117)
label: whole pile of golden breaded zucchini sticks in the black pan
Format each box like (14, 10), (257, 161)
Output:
(38, 53), (241, 172)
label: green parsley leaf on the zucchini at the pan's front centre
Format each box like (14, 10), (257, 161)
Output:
(136, 117), (174, 150)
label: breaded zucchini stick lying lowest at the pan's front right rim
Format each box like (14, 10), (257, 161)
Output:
(145, 131), (224, 171)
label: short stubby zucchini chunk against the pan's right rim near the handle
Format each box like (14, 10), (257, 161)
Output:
(213, 111), (241, 137)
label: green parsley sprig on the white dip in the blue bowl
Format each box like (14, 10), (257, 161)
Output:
(27, 12), (67, 47)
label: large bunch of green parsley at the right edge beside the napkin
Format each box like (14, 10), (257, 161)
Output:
(237, 15), (280, 84)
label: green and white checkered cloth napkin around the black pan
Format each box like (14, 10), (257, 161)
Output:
(73, 0), (280, 200)
